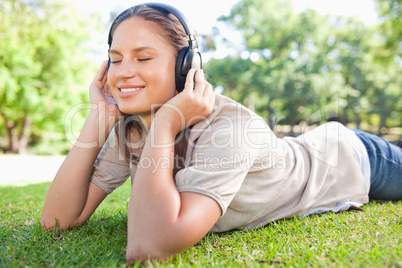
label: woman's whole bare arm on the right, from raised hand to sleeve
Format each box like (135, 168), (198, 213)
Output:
(127, 69), (221, 261)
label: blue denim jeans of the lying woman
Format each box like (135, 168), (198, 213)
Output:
(351, 129), (402, 200)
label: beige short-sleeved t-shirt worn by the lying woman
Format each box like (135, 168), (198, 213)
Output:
(91, 95), (368, 232)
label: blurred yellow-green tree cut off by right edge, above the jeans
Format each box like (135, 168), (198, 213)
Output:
(372, 0), (402, 135)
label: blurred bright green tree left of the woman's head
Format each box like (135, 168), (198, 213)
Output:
(0, 0), (94, 153)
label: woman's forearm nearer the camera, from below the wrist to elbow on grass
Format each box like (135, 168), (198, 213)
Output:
(127, 122), (191, 255)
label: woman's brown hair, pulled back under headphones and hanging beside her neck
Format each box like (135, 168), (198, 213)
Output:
(108, 5), (189, 176)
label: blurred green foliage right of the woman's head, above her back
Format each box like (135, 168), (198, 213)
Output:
(207, 0), (402, 134)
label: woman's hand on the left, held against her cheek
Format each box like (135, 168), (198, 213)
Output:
(89, 61), (122, 119)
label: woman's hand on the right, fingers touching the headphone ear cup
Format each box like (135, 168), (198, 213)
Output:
(154, 69), (215, 134)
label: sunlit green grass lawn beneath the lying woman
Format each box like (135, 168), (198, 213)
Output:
(0, 182), (402, 267)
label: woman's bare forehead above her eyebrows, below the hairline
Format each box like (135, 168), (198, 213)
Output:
(111, 17), (169, 48)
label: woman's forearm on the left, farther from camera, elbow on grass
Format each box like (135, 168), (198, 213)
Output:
(41, 111), (113, 229)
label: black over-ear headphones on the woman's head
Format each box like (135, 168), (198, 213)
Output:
(108, 3), (202, 92)
